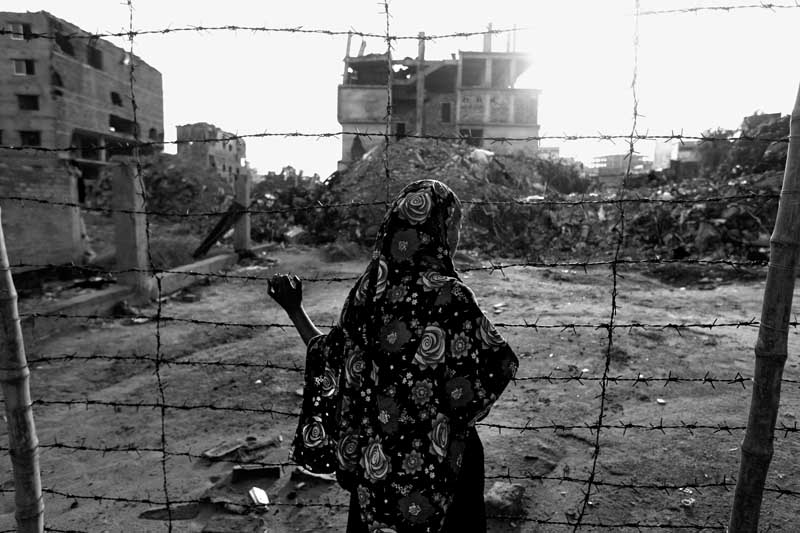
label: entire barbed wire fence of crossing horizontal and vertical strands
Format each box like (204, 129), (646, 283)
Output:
(0, 0), (800, 532)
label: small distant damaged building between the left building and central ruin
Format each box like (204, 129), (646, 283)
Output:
(176, 122), (249, 183)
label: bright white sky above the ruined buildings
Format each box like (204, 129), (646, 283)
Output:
(10, 0), (800, 177)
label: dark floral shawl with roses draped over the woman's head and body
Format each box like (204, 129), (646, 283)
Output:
(291, 180), (518, 533)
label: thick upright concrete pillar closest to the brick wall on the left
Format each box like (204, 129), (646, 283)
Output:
(108, 161), (155, 304)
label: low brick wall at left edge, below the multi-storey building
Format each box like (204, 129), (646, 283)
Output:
(0, 153), (83, 271)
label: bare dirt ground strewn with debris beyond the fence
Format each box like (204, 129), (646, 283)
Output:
(0, 248), (800, 532)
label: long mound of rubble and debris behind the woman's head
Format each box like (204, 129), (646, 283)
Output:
(254, 139), (782, 262)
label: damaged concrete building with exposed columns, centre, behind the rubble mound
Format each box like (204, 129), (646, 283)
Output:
(338, 27), (541, 168)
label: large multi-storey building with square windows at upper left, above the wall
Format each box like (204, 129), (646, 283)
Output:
(0, 11), (164, 200)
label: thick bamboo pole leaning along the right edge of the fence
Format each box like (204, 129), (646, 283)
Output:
(728, 83), (800, 533)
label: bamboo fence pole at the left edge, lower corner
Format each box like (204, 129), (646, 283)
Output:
(0, 208), (44, 533)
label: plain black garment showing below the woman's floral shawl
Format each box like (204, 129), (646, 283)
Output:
(347, 427), (486, 533)
